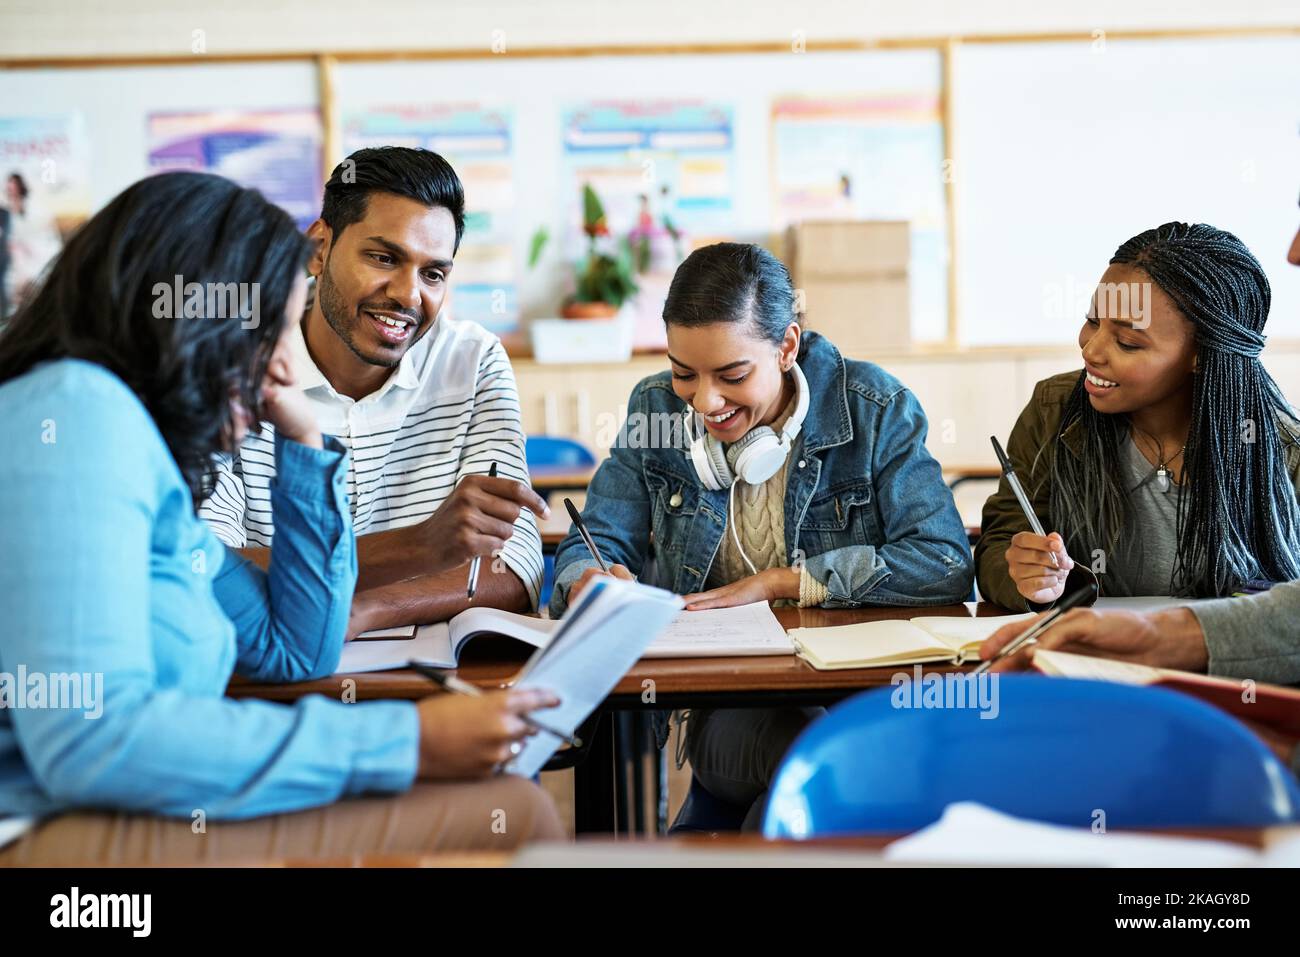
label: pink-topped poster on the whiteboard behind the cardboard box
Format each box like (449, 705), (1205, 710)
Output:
(772, 91), (948, 341)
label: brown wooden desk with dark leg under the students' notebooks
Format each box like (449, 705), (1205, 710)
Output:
(228, 602), (1010, 833)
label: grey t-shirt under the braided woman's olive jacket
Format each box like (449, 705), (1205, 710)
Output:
(1100, 437), (1183, 596)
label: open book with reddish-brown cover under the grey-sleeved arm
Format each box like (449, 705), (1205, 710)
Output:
(1034, 648), (1300, 736)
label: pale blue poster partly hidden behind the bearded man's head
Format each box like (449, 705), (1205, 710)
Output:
(343, 103), (520, 335)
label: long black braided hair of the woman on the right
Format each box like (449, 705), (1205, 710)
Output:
(1050, 222), (1300, 597)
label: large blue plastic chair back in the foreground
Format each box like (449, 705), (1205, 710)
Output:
(763, 675), (1300, 839)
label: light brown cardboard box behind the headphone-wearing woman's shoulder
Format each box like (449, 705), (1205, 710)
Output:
(785, 220), (911, 359)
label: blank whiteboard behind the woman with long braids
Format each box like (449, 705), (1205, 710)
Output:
(954, 38), (1300, 346)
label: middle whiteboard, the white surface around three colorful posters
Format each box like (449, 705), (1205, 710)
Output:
(332, 49), (945, 339)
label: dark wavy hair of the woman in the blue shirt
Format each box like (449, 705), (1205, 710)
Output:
(0, 173), (311, 503)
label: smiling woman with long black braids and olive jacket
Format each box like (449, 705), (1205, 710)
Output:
(975, 222), (1300, 609)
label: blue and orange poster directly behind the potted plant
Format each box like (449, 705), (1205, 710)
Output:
(562, 100), (736, 348)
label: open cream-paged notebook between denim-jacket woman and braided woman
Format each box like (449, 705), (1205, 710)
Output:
(790, 614), (1034, 671)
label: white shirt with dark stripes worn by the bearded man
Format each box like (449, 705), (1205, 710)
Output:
(199, 316), (542, 609)
